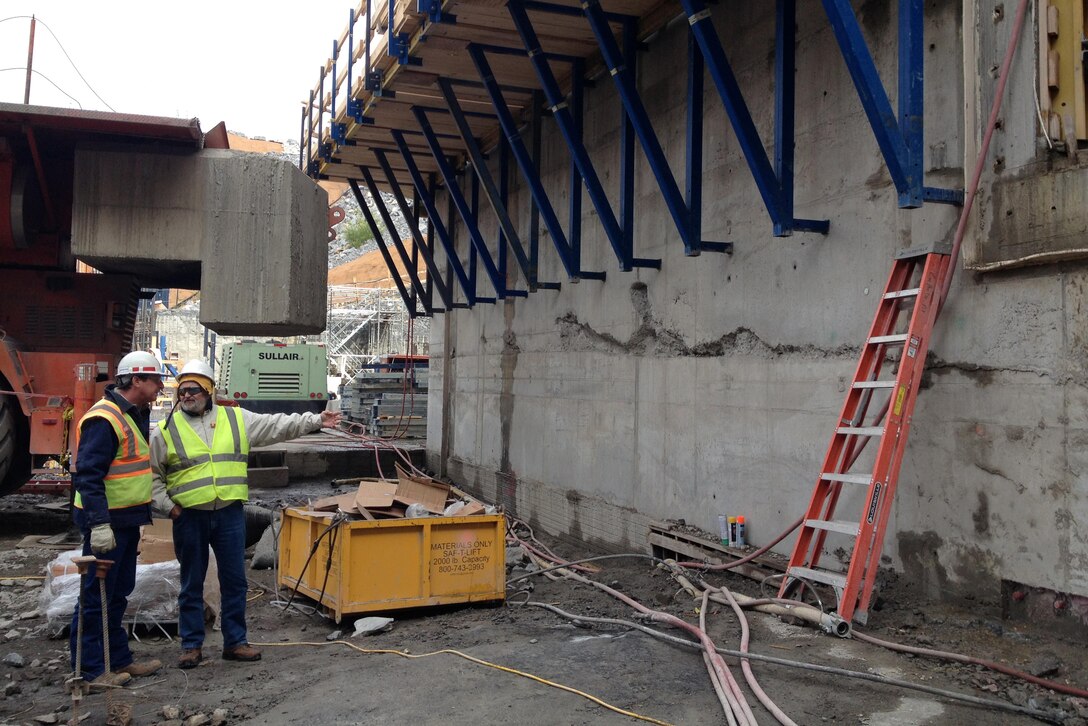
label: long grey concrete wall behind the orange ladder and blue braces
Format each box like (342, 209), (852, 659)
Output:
(428, 1), (1088, 599)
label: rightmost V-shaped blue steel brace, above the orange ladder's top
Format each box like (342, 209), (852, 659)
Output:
(823, 0), (963, 209)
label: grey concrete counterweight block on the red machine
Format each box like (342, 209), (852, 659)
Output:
(72, 149), (329, 335)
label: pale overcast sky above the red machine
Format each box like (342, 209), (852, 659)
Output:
(0, 0), (358, 141)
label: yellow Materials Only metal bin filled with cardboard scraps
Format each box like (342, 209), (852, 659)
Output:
(280, 509), (506, 623)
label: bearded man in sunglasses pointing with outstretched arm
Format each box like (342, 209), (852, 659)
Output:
(151, 360), (341, 668)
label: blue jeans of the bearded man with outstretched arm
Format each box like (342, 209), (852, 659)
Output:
(174, 502), (248, 649)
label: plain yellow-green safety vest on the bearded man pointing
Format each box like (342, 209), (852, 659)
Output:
(159, 406), (249, 507)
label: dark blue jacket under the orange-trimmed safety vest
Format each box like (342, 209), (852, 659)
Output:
(72, 384), (151, 531)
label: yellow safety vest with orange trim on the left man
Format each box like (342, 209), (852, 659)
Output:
(75, 398), (151, 509)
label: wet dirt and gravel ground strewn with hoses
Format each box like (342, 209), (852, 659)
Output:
(0, 482), (1088, 726)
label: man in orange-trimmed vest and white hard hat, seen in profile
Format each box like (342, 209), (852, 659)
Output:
(70, 350), (163, 689)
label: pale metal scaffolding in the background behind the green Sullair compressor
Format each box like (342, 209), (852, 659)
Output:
(324, 285), (430, 379)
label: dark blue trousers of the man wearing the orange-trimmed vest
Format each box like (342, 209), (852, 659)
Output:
(69, 527), (139, 680)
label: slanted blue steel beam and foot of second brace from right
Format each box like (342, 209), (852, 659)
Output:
(680, 0), (829, 236)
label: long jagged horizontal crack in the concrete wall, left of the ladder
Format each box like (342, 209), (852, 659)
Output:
(555, 282), (860, 358)
